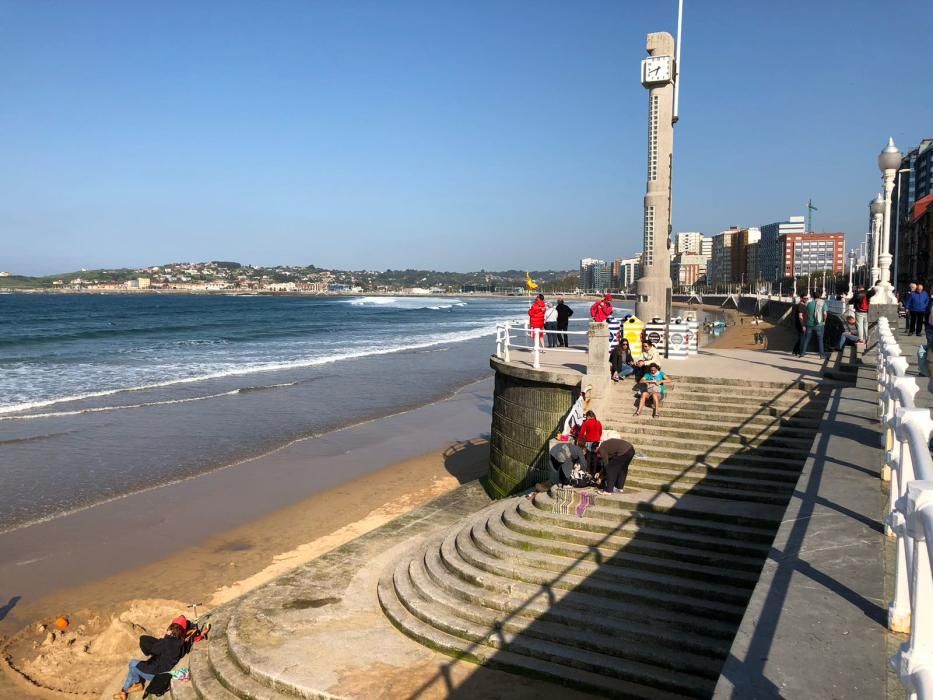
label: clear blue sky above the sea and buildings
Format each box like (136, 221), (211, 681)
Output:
(0, 0), (933, 274)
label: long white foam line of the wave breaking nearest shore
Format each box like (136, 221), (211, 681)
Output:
(0, 325), (496, 420)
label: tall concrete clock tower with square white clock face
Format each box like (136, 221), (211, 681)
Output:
(635, 32), (676, 321)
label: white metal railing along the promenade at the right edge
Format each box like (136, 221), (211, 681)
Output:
(877, 318), (933, 700)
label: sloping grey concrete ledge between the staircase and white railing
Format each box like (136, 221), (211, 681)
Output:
(713, 370), (886, 699)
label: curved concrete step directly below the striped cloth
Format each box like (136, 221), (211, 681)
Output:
(517, 501), (770, 557)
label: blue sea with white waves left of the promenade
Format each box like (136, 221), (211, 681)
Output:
(0, 294), (589, 532)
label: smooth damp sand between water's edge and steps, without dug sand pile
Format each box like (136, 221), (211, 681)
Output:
(0, 379), (492, 636)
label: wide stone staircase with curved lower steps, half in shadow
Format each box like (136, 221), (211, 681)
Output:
(173, 378), (826, 700)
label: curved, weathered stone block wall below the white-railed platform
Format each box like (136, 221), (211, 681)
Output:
(487, 366), (580, 498)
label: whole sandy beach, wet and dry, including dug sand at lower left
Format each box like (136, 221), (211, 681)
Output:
(0, 380), (491, 698)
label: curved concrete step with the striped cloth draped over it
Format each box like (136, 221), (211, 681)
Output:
(519, 489), (774, 544)
